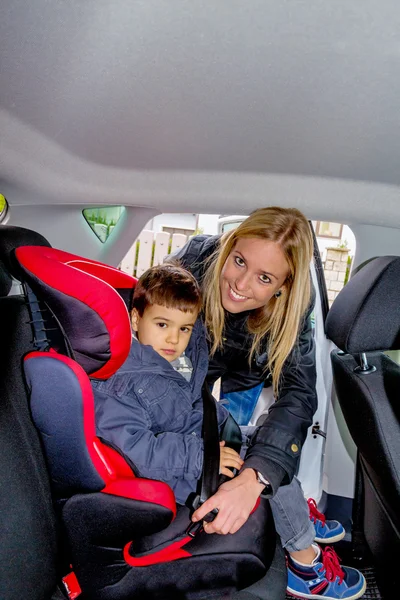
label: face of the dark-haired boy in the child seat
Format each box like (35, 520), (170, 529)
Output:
(131, 304), (198, 362)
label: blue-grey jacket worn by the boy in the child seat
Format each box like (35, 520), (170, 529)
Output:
(92, 319), (228, 504)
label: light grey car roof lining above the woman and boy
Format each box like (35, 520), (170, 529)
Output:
(0, 0), (400, 227)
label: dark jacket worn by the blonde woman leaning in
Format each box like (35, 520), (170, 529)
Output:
(167, 235), (317, 494)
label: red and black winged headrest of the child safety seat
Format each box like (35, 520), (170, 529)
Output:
(15, 246), (136, 379)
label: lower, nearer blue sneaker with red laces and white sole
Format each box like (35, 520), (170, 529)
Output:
(287, 547), (366, 600)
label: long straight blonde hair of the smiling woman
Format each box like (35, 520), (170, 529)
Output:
(203, 206), (313, 395)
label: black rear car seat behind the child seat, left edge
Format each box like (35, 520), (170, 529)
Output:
(0, 225), (59, 600)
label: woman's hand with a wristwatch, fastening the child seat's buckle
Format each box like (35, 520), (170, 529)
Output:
(192, 469), (265, 535)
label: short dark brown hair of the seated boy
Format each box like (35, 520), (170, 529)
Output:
(131, 264), (202, 317)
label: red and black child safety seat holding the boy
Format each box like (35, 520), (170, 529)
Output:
(7, 240), (275, 600)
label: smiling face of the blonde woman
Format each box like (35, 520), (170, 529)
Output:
(220, 238), (289, 313)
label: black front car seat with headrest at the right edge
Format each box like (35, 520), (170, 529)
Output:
(326, 256), (400, 597)
